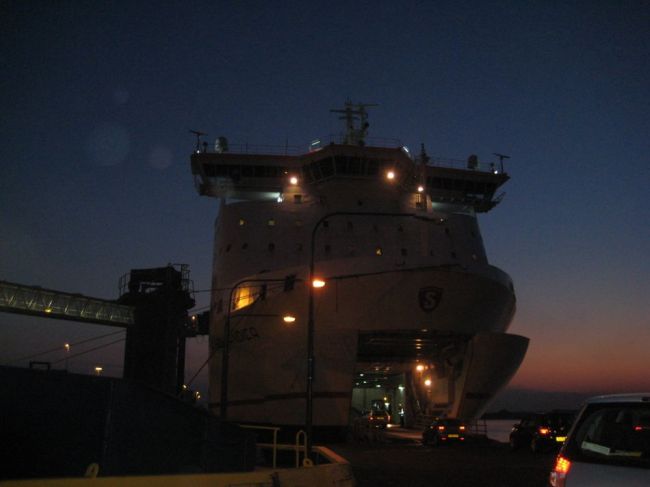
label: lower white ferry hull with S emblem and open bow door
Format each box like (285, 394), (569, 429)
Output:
(211, 263), (528, 427)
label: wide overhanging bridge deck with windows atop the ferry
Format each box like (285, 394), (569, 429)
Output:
(191, 143), (509, 213)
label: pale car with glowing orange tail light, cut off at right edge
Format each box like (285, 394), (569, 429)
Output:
(550, 392), (650, 487)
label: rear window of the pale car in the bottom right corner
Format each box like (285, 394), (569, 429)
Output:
(567, 403), (650, 468)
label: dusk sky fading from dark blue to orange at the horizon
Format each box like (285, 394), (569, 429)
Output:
(0, 0), (650, 410)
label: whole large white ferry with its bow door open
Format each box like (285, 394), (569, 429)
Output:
(191, 102), (528, 434)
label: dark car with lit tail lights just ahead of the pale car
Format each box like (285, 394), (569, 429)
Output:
(510, 411), (575, 453)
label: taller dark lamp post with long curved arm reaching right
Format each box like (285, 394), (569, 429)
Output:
(305, 211), (432, 459)
